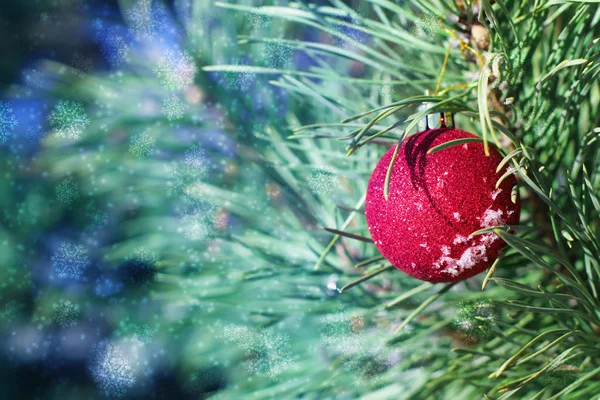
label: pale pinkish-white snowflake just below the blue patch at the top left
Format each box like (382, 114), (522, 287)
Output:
(154, 50), (196, 91)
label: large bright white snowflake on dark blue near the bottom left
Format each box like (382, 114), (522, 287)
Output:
(90, 342), (135, 398)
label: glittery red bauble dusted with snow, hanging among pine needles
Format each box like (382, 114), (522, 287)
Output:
(365, 128), (521, 282)
